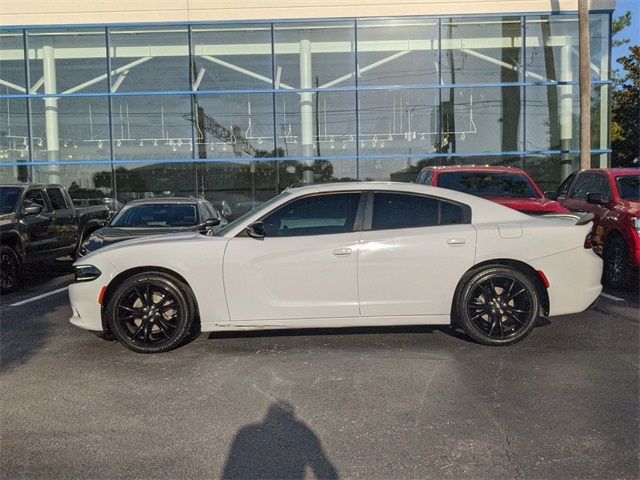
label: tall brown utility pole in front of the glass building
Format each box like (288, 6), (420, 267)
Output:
(578, 0), (591, 168)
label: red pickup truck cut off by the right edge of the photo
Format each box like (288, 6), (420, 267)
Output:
(555, 168), (640, 288)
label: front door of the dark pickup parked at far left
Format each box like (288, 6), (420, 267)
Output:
(18, 187), (56, 261)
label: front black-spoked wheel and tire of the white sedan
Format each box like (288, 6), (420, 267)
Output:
(107, 272), (195, 353)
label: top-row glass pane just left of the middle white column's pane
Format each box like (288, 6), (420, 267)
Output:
(192, 25), (273, 90)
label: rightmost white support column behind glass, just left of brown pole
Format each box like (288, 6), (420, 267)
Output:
(558, 43), (579, 180)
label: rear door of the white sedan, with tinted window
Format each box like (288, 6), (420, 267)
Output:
(358, 192), (476, 317)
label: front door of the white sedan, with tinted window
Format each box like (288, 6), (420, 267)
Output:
(224, 192), (364, 321)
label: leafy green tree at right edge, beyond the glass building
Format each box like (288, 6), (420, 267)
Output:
(611, 45), (640, 167)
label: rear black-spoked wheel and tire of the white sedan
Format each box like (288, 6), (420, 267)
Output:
(454, 266), (540, 345)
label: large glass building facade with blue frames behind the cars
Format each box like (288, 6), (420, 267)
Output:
(0, 13), (611, 212)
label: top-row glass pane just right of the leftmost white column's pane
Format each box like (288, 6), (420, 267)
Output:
(109, 27), (190, 92)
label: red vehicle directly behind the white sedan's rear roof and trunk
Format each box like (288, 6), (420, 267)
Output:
(416, 165), (569, 215)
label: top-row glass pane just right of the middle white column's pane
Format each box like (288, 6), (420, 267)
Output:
(358, 19), (439, 85)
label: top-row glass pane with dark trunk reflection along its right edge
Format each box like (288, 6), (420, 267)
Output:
(441, 17), (522, 84)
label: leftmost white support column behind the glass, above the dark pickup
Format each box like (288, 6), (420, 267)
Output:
(42, 45), (61, 183)
